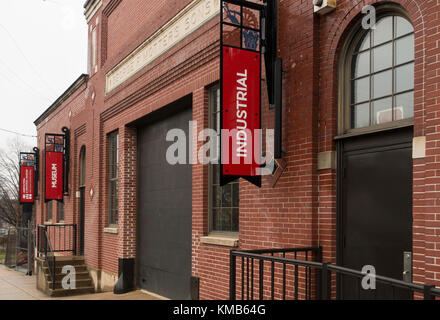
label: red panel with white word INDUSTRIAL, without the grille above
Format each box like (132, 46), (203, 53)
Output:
(222, 47), (261, 177)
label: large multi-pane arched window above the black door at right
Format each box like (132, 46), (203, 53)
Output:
(340, 8), (414, 133)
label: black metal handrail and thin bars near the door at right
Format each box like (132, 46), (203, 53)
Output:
(229, 247), (440, 300)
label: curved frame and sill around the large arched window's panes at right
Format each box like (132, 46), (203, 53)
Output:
(337, 4), (414, 137)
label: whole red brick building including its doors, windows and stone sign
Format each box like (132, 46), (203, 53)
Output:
(35, 0), (440, 299)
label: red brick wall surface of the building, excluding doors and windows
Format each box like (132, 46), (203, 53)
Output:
(37, 0), (440, 299)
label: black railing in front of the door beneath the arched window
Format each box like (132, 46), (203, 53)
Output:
(229, 247), (440, 300)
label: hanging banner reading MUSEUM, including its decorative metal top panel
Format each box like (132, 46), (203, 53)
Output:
(45, 134), (64, 202)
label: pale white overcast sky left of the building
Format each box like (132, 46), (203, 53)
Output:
(0, 0), (87, 151)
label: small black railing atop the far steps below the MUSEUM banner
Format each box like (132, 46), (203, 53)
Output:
(37, 224), (77, 255)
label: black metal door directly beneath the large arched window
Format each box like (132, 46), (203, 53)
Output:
(339, 127), (413, 299)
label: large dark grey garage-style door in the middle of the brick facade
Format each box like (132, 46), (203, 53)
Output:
(138, 109), (192, 299)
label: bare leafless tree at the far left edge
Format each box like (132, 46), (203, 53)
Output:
(0, 137), (31, 226)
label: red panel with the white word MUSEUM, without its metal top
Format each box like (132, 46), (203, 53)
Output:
(46, 152), (63, 201)
